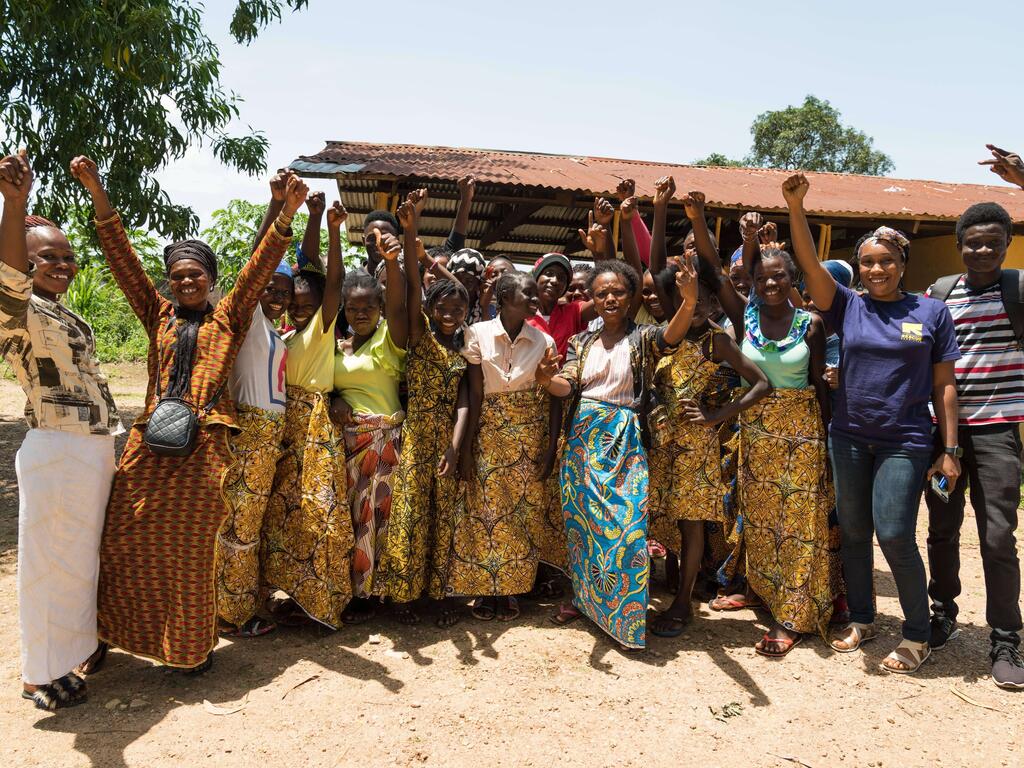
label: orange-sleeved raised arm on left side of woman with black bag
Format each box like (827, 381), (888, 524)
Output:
(71, 156), (167, 335)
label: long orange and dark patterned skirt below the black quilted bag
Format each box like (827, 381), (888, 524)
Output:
(97, 424), (231, 668)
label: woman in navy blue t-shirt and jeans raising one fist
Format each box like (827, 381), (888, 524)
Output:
(782, 173), (961, 674)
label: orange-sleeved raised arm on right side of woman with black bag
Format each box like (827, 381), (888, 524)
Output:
(222, 176), (309, 332)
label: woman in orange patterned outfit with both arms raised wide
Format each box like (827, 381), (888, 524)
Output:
(72, 158), (307, 672)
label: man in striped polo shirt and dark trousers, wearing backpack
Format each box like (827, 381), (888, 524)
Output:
(926, 203), (1024, 688)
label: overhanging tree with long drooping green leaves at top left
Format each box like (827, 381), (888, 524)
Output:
(0, 0), (309, 238)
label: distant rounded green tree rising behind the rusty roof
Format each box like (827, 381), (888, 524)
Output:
(693, 96), (895, 176)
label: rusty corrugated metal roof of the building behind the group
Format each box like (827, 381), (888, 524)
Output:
(291, 141), (1024, 222)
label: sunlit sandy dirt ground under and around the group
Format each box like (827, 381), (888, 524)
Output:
(0, 366), (1024, 768)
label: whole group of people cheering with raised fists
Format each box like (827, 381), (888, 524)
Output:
(0, 147), (1024, 710)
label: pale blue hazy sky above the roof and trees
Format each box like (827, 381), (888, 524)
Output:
(153, 0), (1024, 230)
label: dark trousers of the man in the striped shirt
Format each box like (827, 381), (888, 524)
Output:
(926, 424), (1021, 645)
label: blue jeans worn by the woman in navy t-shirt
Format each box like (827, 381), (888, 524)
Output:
(829, 434), (931, 642)
